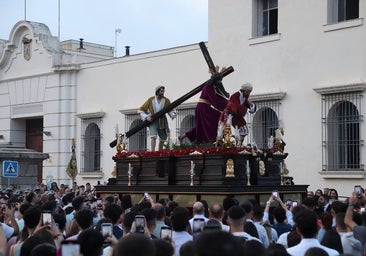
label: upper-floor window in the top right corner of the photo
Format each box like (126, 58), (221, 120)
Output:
(328, 0), (359, 23)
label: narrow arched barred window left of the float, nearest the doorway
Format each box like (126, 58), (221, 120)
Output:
(82, 122), (101, 172)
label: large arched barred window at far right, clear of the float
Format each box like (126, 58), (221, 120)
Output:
(315, 85), (363, 171)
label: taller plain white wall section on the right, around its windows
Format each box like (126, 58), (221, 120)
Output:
(208, 0), (366, 196)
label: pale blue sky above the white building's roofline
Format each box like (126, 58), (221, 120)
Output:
(0, 0), (209, 56)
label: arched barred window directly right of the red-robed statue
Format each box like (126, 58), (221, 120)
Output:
(246, 93), (285, 148)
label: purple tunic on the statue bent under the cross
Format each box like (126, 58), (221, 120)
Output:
(186, 83), (227, 144)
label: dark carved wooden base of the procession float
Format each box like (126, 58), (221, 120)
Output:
(95, 151), (308, 206)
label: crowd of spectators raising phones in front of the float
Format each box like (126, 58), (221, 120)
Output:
(0, 182), (366, 256)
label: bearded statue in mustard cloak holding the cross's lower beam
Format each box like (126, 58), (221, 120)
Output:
(138, 85), (176, 151)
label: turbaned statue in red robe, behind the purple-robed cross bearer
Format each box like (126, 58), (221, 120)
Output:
(217, 83), (256, 146)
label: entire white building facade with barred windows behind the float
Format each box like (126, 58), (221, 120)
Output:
(0, 0), (366, 196)
